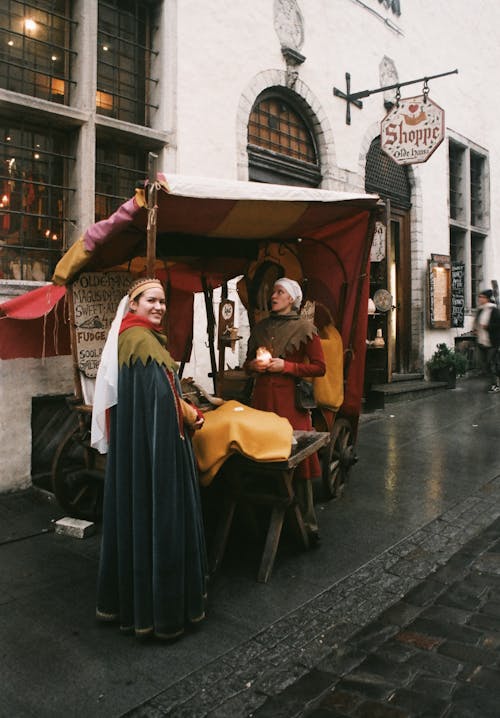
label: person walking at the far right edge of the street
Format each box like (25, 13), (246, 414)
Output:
(474, 289), (500, 394)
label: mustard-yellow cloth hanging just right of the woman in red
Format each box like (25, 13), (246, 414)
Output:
(313, 324), (344, 411)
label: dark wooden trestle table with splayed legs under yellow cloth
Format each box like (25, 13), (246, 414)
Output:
(209, 431), (330, 583)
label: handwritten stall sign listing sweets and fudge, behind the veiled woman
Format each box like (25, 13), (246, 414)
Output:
(71, 272), (132, 378)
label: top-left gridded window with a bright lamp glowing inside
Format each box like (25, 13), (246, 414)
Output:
(0, 0), (76, 104)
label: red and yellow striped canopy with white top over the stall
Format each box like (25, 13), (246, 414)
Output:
(0, 174), (378, 422)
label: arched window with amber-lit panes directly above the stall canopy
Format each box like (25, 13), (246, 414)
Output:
(248, 90), (321, 187)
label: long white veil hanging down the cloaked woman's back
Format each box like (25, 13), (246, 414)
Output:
(90, 294), (129, 454)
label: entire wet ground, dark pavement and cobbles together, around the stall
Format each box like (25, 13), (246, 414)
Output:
(0, 379), (500, 718)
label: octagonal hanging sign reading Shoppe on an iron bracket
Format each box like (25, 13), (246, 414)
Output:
(380, 92), (445, 165)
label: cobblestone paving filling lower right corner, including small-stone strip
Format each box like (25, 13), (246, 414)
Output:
(128, 477), (500, 718)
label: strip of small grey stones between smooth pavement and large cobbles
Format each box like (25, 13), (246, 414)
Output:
(124, 476), (500, 718)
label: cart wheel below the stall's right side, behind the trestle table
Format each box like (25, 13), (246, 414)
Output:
(322, 418), (357, 499)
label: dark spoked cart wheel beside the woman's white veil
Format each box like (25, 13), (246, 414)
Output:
(52, 427), (104, 521)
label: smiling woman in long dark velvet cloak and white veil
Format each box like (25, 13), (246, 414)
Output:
(91, 279), (207, 639)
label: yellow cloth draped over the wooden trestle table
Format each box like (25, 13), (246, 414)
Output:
(193, 401), (293, 486)
